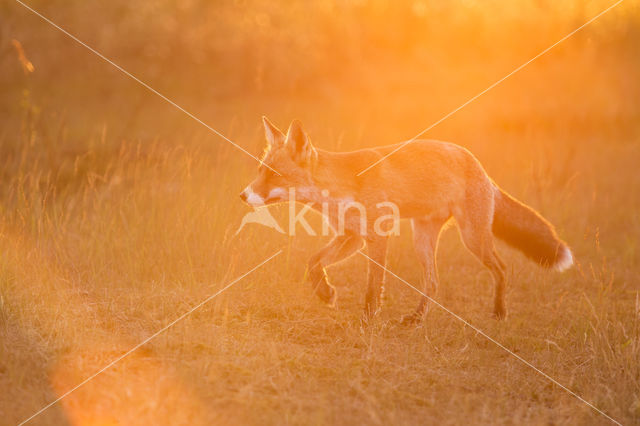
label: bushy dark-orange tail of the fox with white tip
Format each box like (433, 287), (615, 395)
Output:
(493, 186), (573, 271)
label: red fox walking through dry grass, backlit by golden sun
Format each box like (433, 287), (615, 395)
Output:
(240, 116), (573, 324)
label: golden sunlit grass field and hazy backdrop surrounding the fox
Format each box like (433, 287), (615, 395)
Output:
(0, 0), (640, 425)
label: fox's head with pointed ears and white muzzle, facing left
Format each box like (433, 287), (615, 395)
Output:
(240, 117), (318, 207)
